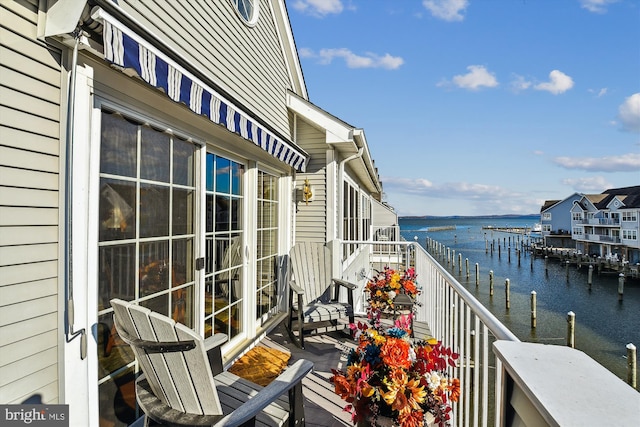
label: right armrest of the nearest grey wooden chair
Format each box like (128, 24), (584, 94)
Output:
(216, 359), (313, 427)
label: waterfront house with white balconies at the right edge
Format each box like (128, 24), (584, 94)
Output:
(571, 186), (640, 264)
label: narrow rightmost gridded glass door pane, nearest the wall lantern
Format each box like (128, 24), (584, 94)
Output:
(256, 171), (279, 323)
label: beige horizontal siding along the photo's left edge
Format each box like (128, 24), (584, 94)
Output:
(0, 0), (61, 403)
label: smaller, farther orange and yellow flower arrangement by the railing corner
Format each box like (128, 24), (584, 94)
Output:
(365, 267), (420, 314)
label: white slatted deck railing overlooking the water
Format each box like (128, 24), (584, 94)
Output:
(343, 241), (519, 427)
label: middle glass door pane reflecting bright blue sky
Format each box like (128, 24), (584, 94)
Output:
(204, 153), (244, 339)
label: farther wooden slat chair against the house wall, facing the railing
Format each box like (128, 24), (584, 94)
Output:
(287, 242), (356, 348)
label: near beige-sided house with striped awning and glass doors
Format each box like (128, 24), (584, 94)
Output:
(0, 0), (397, 426)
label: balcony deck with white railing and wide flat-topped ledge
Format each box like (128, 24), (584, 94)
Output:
(264, 241), (640, 427)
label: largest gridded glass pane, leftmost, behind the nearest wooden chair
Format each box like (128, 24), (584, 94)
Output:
(96, 110), (197, 426)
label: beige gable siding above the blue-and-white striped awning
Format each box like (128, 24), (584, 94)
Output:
(112, 0), (293, 139)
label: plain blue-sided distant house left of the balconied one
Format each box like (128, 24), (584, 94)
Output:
(540, 193), (582, 248)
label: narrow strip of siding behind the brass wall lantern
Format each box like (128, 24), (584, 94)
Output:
(296, 118), (327, 243)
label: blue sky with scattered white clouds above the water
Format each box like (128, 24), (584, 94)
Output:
(286, 0), (640, 215)
